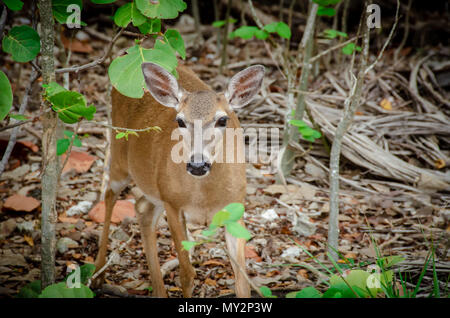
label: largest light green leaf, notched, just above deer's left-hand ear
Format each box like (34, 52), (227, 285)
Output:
(108, 40), (178, 98)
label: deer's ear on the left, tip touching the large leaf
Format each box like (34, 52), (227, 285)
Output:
(142, 63), (182, 108)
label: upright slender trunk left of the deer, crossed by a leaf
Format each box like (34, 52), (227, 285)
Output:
(39, 0), (59, 288)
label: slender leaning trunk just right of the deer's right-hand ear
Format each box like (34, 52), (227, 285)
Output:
(278, 3), (319, 177)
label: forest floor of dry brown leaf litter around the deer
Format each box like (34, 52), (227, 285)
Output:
(0, 4), (450, 297)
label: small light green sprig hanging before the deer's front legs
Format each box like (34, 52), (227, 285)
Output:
(181, 203), (252, 251)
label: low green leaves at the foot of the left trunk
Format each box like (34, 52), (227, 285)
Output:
(16, 264), (95, 298)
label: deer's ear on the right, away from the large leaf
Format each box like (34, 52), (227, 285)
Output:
(225, 65), (264, 108)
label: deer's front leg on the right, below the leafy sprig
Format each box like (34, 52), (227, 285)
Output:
(225, 220), (250, 298)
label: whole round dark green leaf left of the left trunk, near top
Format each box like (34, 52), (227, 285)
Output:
(2, 25), (41, 63)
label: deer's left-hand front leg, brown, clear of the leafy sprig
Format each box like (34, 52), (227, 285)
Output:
(165, 204), (195, 297)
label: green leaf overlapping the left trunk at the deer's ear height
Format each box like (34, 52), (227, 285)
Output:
(47, 91), (96, 124)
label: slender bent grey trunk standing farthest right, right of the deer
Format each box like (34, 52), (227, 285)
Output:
(328, 2), (370, 260)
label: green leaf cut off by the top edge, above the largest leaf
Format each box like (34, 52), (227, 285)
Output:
(135, 0), (187, 19)
